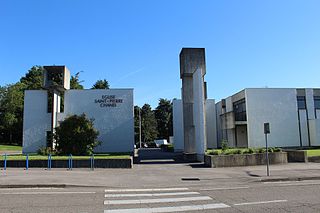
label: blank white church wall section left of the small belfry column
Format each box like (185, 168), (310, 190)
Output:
(22, 90), (51, 153)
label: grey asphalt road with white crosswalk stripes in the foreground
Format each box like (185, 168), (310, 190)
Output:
(0, 180), (320, 213)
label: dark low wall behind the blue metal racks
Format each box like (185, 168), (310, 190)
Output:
(0, 157), (132, 168)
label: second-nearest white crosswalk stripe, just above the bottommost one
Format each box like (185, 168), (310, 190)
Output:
(104, 196), (212, 205)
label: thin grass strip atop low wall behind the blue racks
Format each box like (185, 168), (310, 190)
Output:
(0, 154), (130, 160)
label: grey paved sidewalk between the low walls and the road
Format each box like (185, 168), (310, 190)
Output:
(0, 163), (320, 188)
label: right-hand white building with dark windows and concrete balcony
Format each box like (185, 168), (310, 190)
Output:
(216, 88), (320, 147)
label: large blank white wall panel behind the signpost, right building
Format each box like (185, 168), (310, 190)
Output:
(245, 88), (300, 147)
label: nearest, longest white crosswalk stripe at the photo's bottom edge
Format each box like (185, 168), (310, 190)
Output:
(104, 203), (230, 213)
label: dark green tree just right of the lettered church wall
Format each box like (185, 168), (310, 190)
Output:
(141, 104), (158, 142)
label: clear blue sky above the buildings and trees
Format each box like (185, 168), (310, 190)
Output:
(0, 0), (320, 107)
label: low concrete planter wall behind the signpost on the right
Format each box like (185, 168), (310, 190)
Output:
(204, 152), (288, 168)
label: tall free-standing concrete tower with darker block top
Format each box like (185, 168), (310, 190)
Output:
(180, 48), (206, 161)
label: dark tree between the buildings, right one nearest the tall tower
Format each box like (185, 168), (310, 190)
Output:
(155, 98), (173, 140)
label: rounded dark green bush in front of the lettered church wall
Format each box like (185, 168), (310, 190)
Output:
(54, 114), (100, 155)
